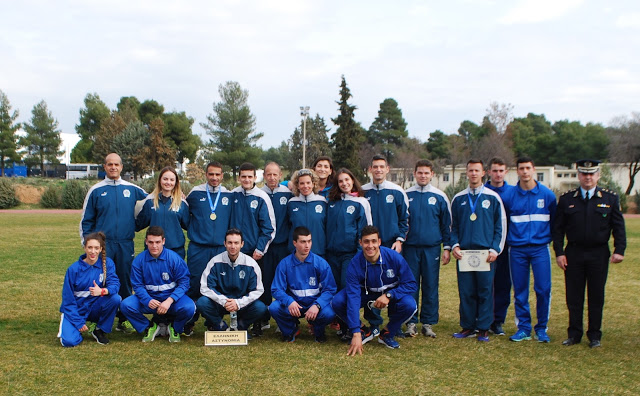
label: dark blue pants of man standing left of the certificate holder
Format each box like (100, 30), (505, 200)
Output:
(402, 245), (440, 325)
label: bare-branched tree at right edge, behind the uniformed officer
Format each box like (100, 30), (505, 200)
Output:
(607, 112), (640, 195)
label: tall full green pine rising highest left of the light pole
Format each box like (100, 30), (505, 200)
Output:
(200, 81), (263, 180)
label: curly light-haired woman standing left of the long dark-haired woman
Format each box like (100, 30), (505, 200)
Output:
(287, 169), (327, 257)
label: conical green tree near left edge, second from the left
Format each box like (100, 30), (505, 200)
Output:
(20, 100), (62, 171)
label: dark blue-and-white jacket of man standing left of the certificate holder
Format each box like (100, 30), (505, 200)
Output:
(405, 184), (451, 249)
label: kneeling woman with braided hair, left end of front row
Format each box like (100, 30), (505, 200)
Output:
(58, 232), (121, 347)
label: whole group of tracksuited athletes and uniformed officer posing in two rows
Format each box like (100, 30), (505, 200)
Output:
(58, 153), (626, 355)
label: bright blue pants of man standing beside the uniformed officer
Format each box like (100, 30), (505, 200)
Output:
(509, 244), (551, 333)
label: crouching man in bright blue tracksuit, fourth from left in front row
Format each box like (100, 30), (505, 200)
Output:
(269, 227), (336, 343)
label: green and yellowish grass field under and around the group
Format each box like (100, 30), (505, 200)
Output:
(0, 212), (640, 395)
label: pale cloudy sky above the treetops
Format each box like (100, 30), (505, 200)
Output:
(0, 0), (640, 159)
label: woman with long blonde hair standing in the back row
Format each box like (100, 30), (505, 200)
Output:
(136, 166), (189, 259)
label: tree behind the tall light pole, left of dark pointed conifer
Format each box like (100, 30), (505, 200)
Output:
(284, 114), (331, 171)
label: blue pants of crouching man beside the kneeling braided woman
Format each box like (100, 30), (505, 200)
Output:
(120, 294), (196, 334)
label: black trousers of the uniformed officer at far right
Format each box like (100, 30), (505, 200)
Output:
(564, 245), (610, 340)
